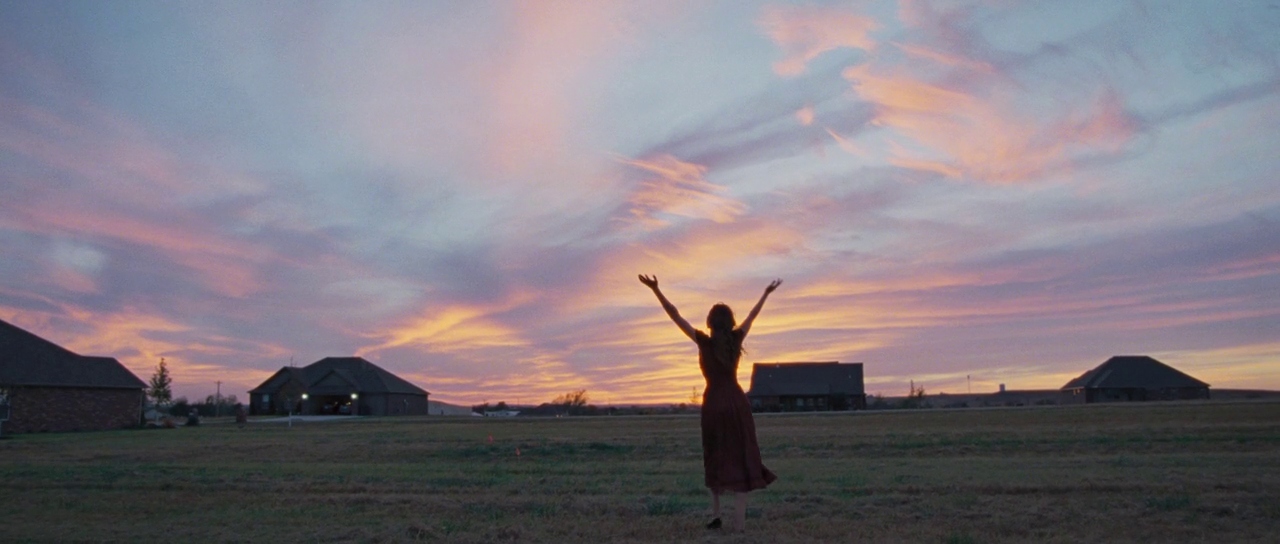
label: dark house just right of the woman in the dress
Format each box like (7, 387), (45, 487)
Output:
(746, 362), (867, 412)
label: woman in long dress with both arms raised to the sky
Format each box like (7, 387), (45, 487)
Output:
(640, 275), (782, 531)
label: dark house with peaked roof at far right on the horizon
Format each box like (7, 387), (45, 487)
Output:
(1062, 356), (1208, 403)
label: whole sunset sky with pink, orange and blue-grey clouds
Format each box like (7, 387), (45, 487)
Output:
(0, 0), (1280, 403)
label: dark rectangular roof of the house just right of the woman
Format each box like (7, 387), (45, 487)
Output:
(748, 362), (864, 397)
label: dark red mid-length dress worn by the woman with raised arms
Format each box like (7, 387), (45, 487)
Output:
(695, 330), (778, 493)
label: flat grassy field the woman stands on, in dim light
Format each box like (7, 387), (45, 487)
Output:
(0, 402), (1280, 543)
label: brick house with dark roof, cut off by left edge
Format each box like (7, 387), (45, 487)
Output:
(0, 320), (146, 433)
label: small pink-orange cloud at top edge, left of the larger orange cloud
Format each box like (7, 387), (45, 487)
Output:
(759, 6), (879, 77)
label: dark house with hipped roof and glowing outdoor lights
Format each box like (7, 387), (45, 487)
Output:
(248, 357), (430, 416)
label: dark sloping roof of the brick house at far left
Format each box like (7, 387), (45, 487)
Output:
(0, 320), (146, 389)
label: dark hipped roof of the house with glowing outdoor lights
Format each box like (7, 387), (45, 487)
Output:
(250, 357), (428, 394)
